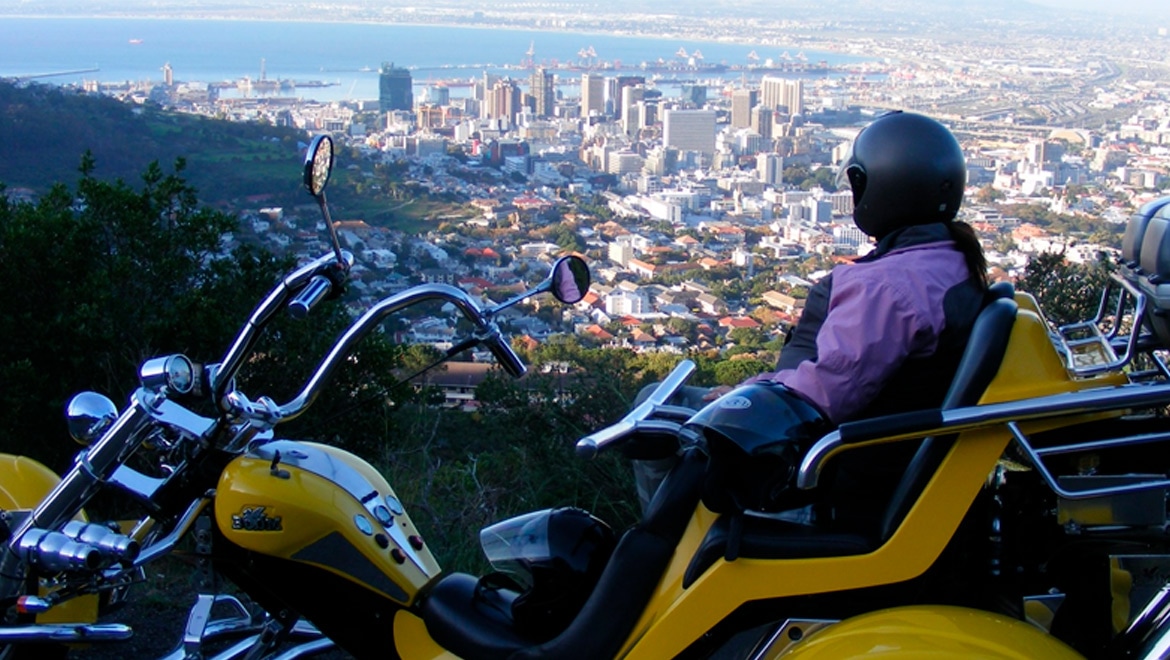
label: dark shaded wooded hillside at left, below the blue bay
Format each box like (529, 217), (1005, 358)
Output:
(0, 82), (303, 201)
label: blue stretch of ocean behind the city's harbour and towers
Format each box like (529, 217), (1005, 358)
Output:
(0, 18), (860, 101)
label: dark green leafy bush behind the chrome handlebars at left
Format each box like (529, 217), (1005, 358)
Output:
(0, 156), (407, 468)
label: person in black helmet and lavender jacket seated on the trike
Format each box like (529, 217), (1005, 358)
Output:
(634, 112), (987, 528)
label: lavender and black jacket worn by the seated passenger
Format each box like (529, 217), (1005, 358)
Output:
(749, 224), (983, 424)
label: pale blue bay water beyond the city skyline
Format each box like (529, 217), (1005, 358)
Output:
(0, 13), (875, 102)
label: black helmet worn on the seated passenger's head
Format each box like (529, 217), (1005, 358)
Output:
(837, 112), (966, 240)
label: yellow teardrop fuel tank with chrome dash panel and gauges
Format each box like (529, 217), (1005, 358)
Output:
(215, 440), (439, 605)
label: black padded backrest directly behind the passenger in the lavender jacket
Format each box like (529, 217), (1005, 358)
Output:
(880, 293), (1018, 541)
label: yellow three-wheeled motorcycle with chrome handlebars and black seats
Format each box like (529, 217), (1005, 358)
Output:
(0, 131), (1170, 660)
